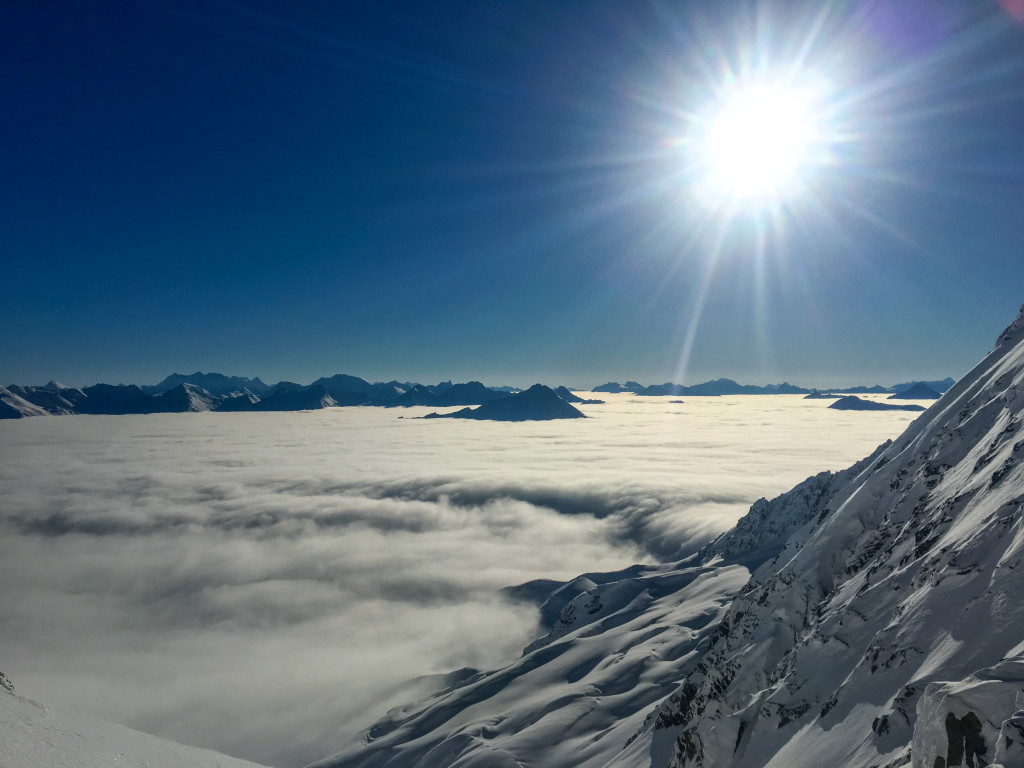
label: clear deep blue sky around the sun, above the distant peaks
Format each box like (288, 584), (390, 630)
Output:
(0, 0), (1024, 386)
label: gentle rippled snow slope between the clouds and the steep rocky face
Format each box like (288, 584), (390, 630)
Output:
(307, 558), (749, 768)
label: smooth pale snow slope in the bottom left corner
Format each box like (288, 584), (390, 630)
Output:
(0, 673), (268, 768)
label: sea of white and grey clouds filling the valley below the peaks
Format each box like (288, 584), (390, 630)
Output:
(0, 395), (915, 768)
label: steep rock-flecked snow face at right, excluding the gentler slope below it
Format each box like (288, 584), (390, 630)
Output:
(630, 308), (1024, 768)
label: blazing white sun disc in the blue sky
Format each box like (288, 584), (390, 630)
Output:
(691, 79), (826, 207)
